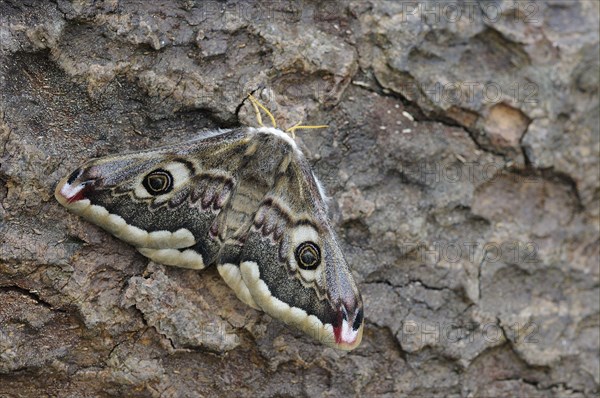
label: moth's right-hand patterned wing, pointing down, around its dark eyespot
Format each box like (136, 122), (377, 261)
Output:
(219, 131), (363, 349)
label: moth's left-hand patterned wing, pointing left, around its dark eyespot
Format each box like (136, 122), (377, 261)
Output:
(56, 129), (250, 269)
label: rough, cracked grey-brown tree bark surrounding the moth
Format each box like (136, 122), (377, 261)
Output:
(0, 0), (600, 397)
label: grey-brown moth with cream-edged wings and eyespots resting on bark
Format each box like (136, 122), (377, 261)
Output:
(55, 123), (363, 350)
